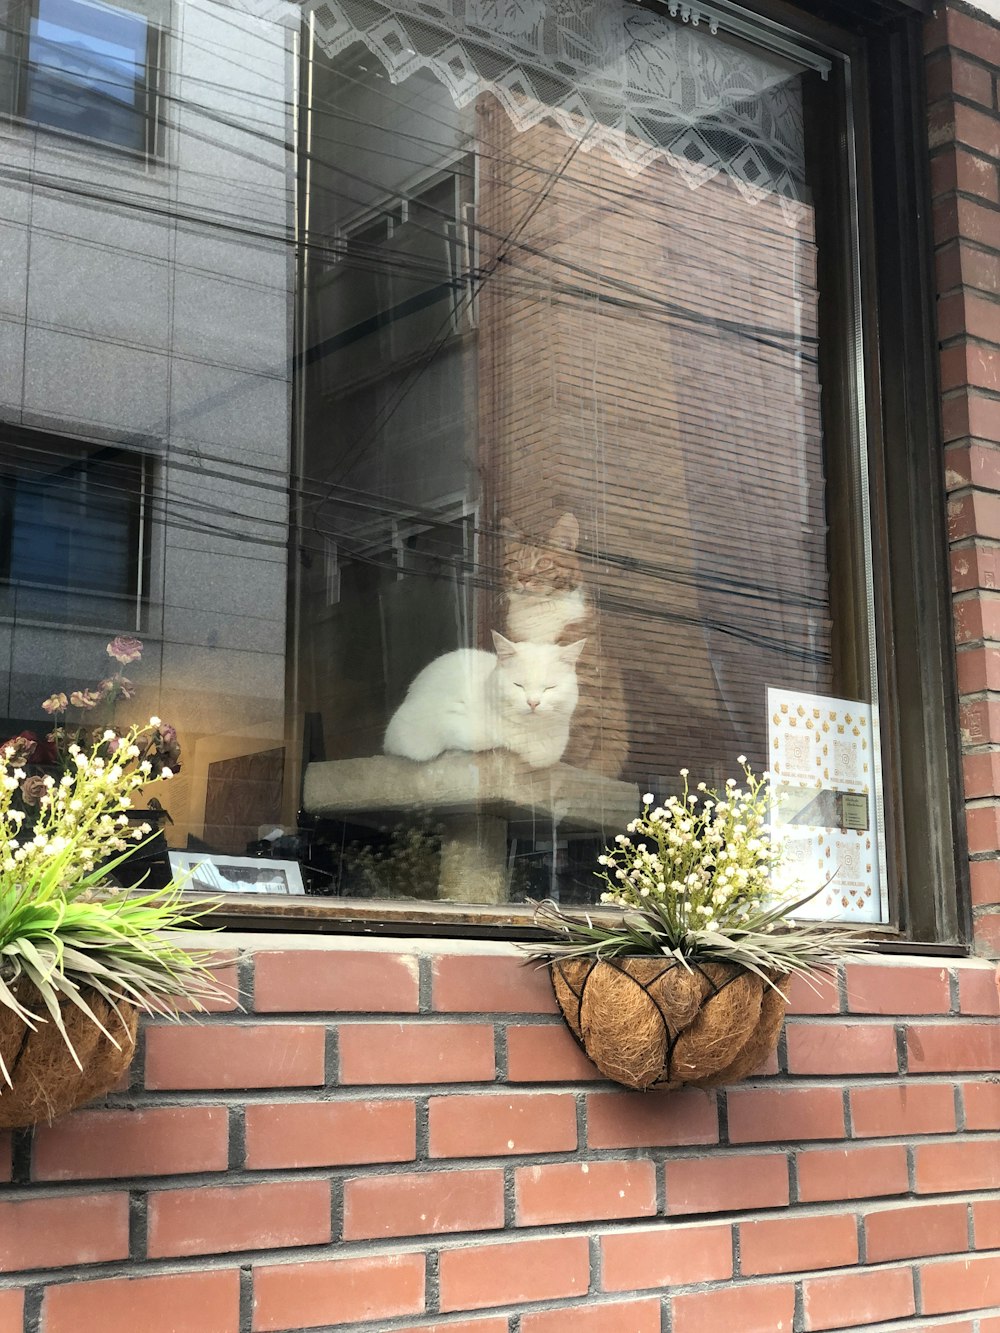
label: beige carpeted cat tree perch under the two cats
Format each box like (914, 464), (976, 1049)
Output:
(303, 750), (640, 902)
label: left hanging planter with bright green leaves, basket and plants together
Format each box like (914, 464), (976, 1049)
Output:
(0, 703), (221, 1128)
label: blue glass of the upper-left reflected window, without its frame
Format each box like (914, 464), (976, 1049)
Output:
(24, 0), (149, 149)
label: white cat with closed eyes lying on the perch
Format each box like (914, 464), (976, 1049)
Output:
(384, 631), (585, 768)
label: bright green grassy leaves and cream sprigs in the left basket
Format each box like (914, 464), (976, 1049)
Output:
(0, 728), (227, 1085)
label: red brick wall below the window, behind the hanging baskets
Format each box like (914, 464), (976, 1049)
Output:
(0, 940), (1000, 1333)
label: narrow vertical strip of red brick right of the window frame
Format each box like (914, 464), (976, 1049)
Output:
(925, 7), (1000, 956)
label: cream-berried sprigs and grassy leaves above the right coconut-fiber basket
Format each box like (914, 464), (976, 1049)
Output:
(525, 757), (869, 982)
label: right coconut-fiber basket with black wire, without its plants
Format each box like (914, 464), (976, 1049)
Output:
(549, 957), (788, 1089)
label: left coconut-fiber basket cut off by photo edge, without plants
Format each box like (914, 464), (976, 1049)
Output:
(0, 986), (139, 1129)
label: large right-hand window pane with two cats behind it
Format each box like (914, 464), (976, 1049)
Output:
(297, 3), (881, 918)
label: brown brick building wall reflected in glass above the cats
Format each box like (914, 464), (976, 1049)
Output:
(477, 96), (832, 789)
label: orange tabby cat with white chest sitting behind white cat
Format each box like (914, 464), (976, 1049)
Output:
(503, 513), (628, 777)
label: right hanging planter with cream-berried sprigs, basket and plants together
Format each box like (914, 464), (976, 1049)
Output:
(525, 756), (868, 1089)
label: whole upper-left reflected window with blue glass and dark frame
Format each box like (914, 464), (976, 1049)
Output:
(4, 0), (160, 153)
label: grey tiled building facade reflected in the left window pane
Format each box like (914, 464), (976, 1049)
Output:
(0, 3), (293, 850)
